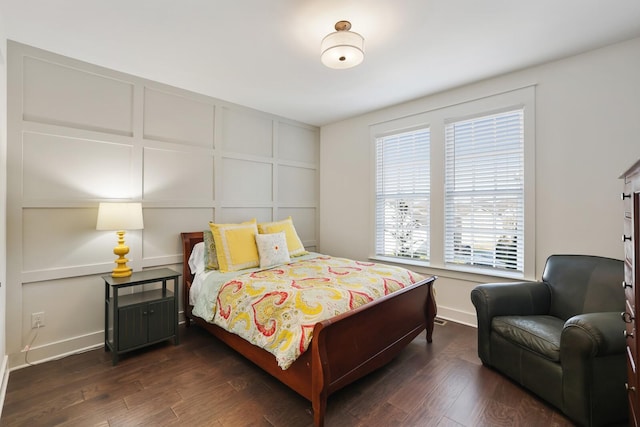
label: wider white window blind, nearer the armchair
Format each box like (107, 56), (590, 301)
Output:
(445, 109), (524, 273)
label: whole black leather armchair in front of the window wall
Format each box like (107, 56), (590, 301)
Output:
(471, 255), (628, 426)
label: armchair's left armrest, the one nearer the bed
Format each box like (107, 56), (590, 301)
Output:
(471, 282), (551, 365)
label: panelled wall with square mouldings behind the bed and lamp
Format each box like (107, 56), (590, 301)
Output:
(6, 41), (319, 368)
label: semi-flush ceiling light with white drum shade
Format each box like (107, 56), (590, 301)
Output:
(320, 21), (364, 69)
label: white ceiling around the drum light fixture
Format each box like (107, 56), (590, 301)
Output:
(0, 0), (640, 125)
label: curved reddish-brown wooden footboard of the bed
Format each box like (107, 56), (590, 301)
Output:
(311, 276), (436, 426)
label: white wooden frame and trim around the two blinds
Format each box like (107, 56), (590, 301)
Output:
(369, 85), (536, 280)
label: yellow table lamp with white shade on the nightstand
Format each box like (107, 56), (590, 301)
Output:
(96, 202), (144, 277)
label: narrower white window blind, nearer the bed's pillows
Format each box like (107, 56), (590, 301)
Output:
(375, 128), (430, 260)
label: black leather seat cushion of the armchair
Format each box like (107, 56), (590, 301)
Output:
(491, 316), (564, 362)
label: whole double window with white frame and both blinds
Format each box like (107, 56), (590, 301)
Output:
(370, 85), (536, 280)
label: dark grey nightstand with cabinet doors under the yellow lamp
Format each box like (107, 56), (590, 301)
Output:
(102, 268), (180, 365)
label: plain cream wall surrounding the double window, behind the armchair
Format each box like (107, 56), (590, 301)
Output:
(320, 39), (640, 324)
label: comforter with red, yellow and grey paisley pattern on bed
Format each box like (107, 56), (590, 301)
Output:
(194, 254), (423, 369)
